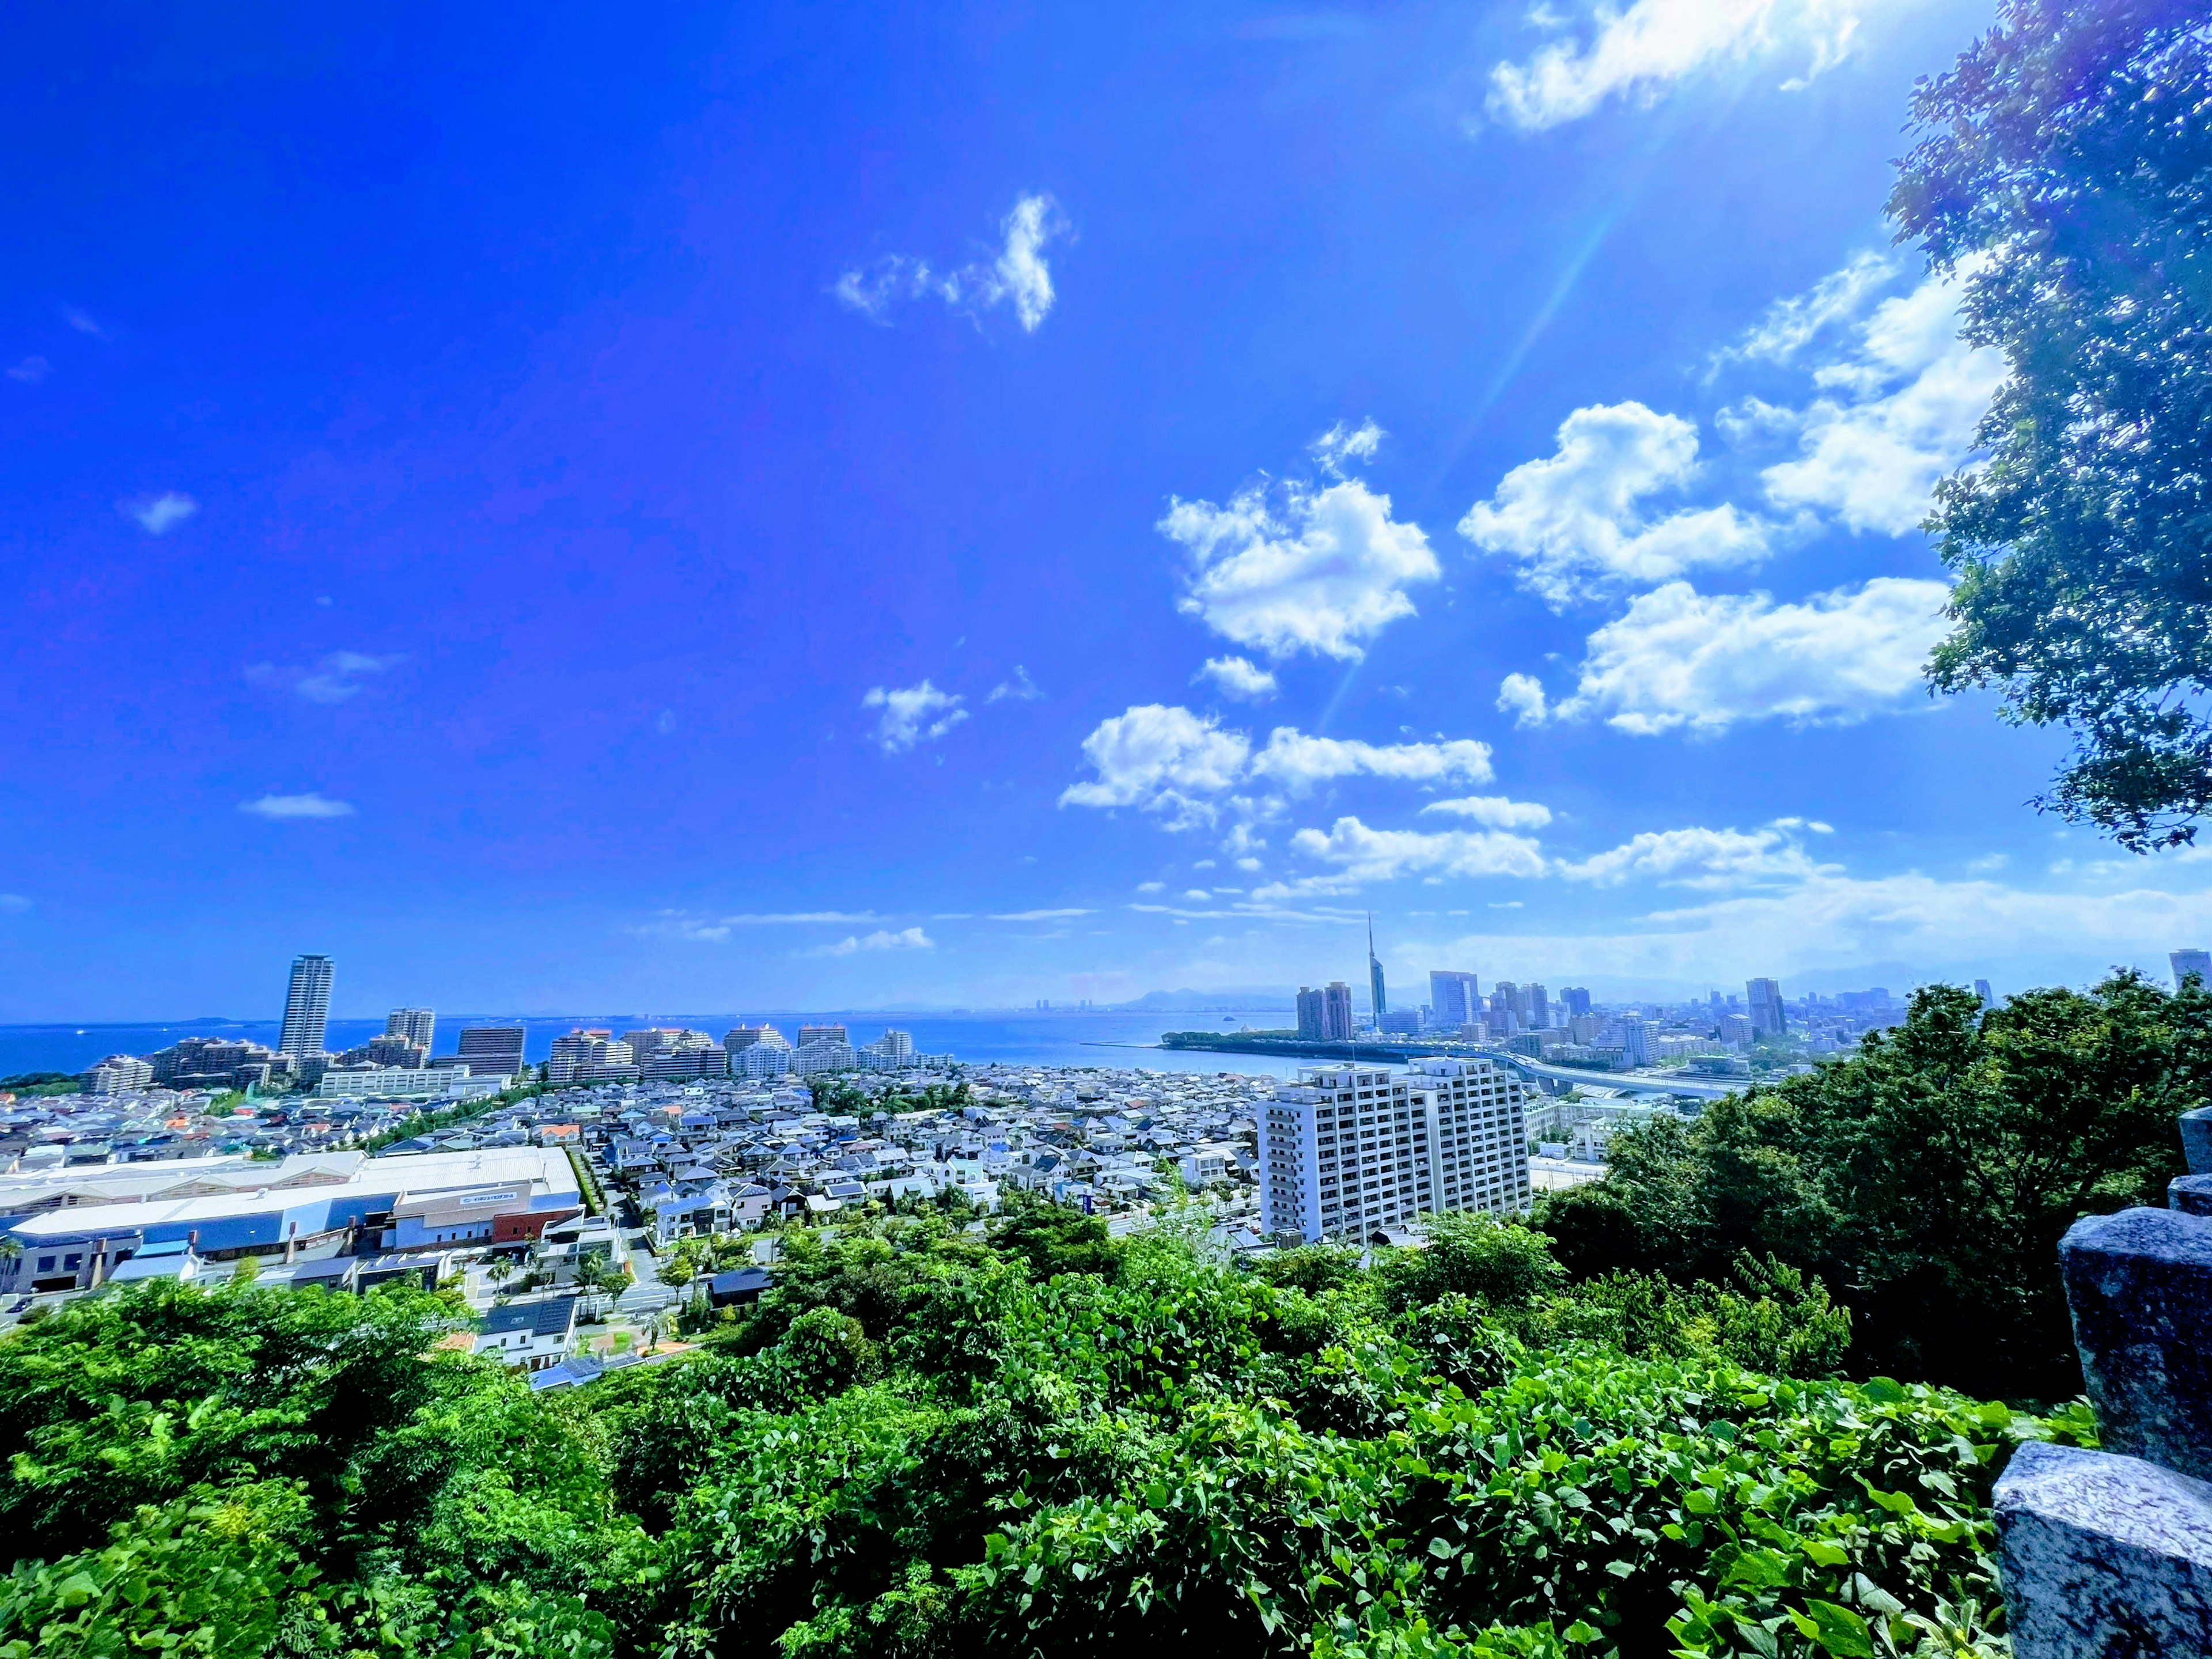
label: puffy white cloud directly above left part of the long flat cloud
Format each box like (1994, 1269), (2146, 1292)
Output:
(1460, 403), (1770, 608)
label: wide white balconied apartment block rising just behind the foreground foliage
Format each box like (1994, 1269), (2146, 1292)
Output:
(1259, 1059), (1528, 1243)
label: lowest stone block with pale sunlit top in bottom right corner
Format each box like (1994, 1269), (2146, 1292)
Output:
(1995, 1445), (2212, 1659)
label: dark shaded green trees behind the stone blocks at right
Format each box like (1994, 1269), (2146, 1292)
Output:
(1540, 974), (2212, 1400)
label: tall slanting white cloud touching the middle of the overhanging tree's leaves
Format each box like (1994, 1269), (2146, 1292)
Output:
(1763, 276), (2006, 535)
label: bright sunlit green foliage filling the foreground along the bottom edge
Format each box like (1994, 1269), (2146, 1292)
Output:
(0, 1208), (2062, 1659)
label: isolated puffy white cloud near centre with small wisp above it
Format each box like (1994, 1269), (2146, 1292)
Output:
(1157, 427), (1438, 661)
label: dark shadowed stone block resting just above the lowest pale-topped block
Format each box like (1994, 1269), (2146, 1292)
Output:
(2059, 1208), (2212, 1480)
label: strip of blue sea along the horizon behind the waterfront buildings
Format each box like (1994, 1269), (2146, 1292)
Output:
(0, 1009), (1296, 1077)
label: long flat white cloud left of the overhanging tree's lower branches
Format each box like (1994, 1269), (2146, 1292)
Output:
(1555, 577), (1949, 737)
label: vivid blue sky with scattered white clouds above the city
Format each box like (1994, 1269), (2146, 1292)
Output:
(0, 0), (2212, 1020)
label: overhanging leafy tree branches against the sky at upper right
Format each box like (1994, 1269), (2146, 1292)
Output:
(1889, 0), (2212, 851)
